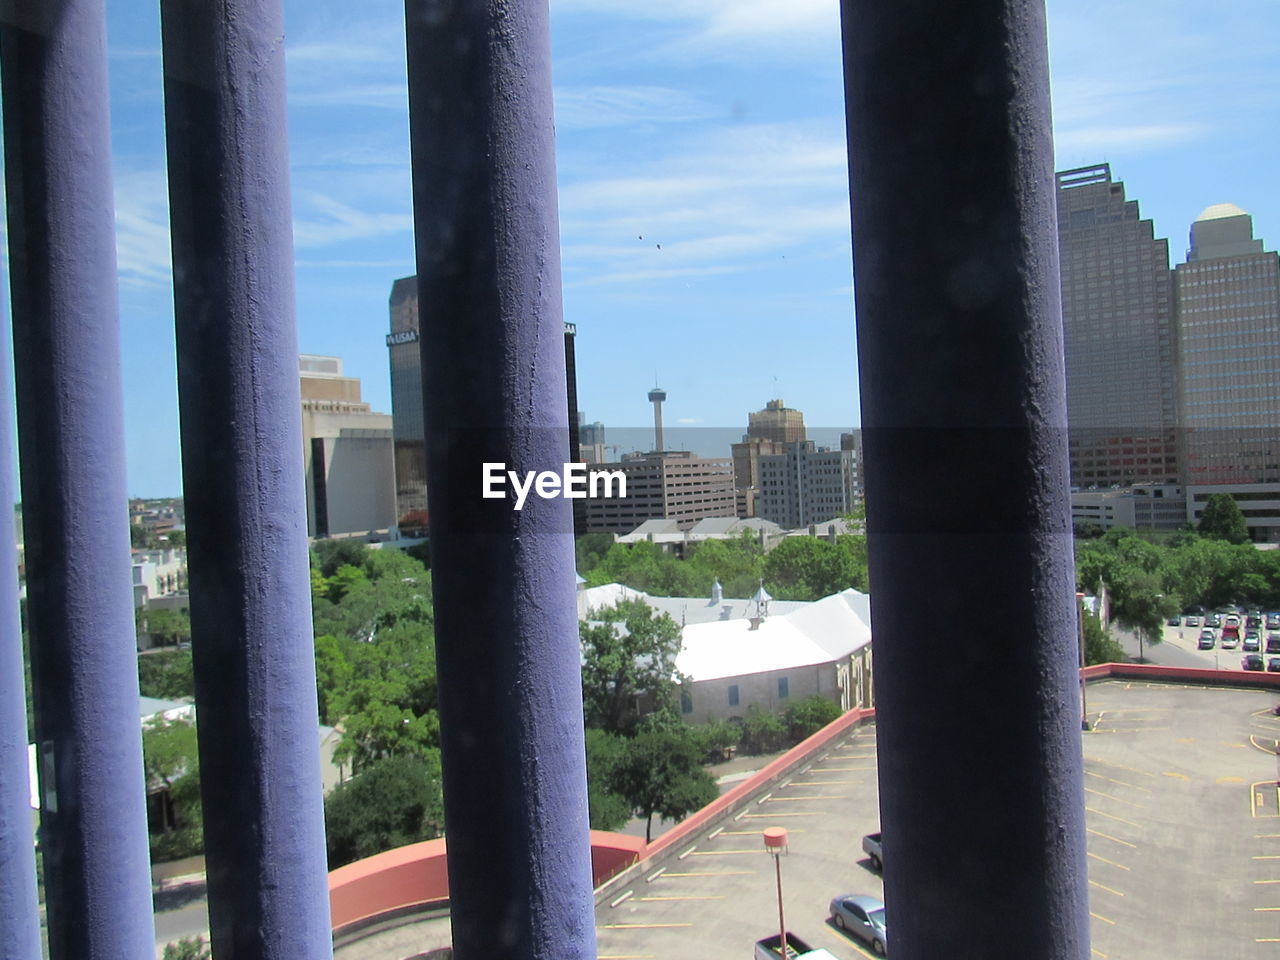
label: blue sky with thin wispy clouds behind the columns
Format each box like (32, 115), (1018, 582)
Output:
(77, 0), (1280, 497)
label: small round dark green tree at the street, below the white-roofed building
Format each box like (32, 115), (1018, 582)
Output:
(612, 730), (719, 844)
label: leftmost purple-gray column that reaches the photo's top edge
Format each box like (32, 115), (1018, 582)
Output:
(0, 0), (155, 960)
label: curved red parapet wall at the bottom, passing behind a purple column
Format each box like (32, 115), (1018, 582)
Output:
(329, 829), (644, 931)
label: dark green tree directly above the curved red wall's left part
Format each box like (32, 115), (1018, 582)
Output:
(324, 750), (444, 869)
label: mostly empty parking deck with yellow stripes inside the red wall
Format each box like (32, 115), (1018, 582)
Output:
(596, 681), (1280, 960)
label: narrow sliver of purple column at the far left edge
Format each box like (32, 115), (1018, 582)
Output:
(0, 316), (41, 960)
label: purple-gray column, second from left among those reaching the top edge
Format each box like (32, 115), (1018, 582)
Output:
(160, 0), (332, 960)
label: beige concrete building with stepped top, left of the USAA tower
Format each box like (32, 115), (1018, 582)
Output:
(298, 355), (396, 536)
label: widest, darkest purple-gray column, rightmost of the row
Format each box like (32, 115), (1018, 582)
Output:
(842, 0), (1089, 960)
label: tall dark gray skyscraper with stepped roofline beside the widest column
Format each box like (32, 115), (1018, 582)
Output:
(1057, 164), (1179, 488)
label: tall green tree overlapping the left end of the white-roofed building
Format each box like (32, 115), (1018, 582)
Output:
(579, 600), (681, 733)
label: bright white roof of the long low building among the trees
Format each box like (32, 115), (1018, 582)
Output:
(676, 589), (872, 681)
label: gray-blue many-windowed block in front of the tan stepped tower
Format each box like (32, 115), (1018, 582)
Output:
(755, 440), (860, 530)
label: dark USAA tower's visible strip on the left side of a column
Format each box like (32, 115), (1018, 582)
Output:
(387, 276), (428, 536)
